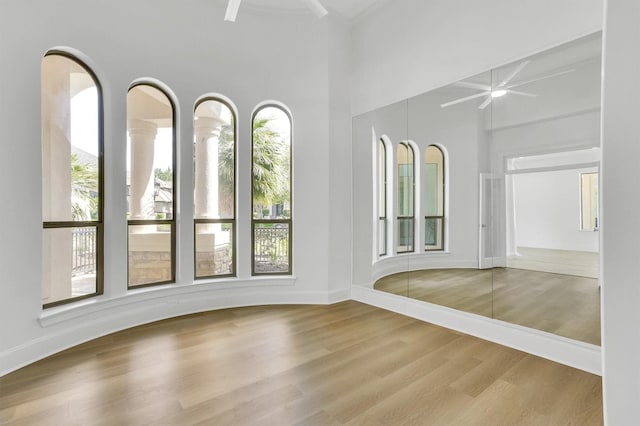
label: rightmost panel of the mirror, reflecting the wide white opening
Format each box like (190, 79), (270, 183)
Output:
(491, 35), (601, 345)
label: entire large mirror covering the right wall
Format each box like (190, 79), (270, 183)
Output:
(353, 33), (602, 345)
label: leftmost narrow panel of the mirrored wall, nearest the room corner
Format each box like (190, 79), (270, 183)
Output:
(352, 101), (410, 296)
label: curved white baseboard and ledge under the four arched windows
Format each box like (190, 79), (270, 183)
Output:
(0, 278), (350, 376)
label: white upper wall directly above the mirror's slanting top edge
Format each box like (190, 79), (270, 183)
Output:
(352, 0), (602, 115)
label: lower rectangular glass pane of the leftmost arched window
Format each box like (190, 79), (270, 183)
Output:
(42, 226), (98, 304)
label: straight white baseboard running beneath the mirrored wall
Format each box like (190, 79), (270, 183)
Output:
(351, 286), (602, 375)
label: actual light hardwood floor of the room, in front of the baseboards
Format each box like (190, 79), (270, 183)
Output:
(0, 301), (603, 426)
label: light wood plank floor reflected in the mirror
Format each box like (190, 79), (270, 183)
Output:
(374, 268), (600, 345)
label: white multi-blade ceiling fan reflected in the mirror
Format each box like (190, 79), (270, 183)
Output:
(440, 60), (575, 109)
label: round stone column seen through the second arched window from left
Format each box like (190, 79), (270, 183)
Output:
(128, 119), (158, 220)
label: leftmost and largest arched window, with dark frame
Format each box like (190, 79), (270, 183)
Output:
(41, 51), (104, 308)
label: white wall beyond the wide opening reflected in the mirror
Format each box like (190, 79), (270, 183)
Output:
(512, 169), (599, 252)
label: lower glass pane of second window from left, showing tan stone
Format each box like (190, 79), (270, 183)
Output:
(128, 224), (173, 287)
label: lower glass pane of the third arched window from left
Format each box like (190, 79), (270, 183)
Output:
(195, 222), (234, 278)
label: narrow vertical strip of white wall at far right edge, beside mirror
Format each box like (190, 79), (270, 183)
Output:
(601, 0), (640, 426)
